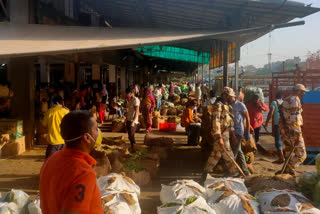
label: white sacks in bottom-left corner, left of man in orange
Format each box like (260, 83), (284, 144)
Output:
(0, 189), (42, 214)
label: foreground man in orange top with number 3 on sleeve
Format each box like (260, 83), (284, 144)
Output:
(40, 111), (103, 214)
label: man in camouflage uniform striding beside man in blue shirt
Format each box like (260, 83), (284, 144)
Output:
(201, 87), (237, 183)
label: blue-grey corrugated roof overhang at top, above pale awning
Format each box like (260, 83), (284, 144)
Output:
(93, 0), (319, 30)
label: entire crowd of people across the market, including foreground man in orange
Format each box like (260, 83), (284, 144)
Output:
(40, 77), (307, 213)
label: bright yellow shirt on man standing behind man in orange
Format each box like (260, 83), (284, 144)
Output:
(42, 105), (69, 145)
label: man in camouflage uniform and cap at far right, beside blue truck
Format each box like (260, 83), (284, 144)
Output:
(276, 84), (308, 175)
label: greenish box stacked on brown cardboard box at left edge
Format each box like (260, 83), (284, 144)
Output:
(0, 119), (23, 139)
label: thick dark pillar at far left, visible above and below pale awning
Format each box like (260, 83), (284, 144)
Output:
(8, 0), (35, 149)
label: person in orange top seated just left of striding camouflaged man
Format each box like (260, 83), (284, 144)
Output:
(181, 100), (201, 146)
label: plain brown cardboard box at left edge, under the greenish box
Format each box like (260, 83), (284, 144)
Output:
(1, 136), (26, 157)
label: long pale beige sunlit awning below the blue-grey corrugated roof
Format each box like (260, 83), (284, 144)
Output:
(0, 24), (272, 58)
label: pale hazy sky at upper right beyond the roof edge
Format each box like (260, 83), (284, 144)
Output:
(240, 0), (320, 67)
